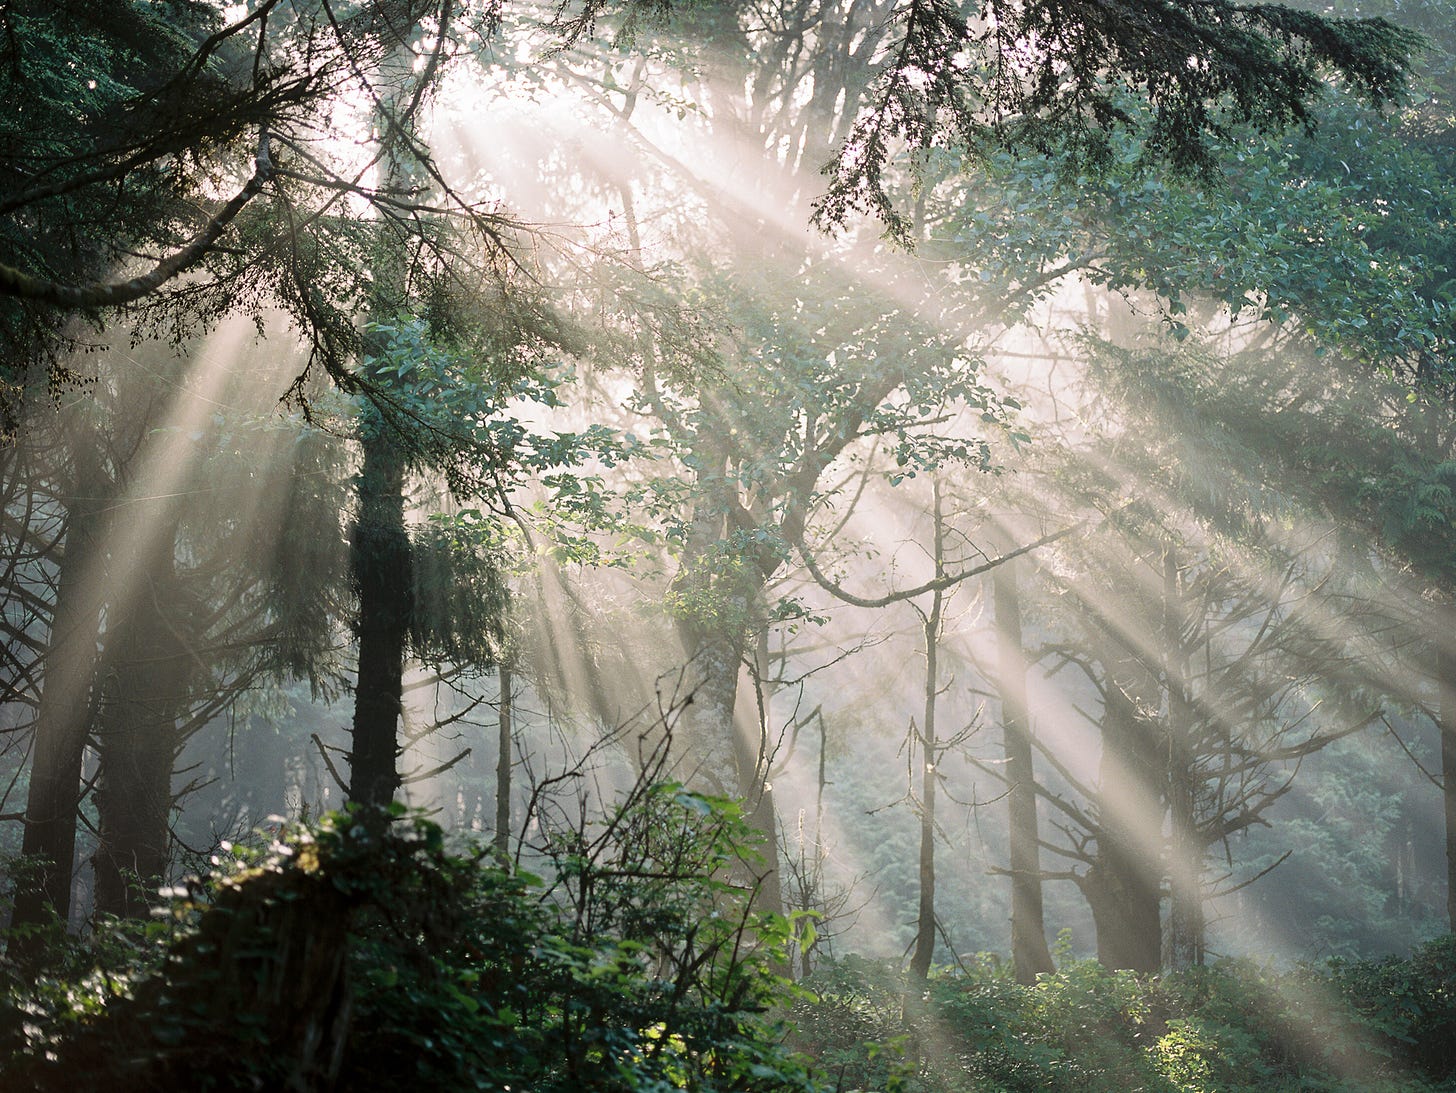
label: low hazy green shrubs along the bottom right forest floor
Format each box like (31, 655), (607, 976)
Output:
(794, 937), (1456, 1093)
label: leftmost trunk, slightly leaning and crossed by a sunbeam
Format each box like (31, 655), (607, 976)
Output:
(10, 437), (109, 961)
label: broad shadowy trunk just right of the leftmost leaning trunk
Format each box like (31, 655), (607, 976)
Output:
(93, 524), (192, 918)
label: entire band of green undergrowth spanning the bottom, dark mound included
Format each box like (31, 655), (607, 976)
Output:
(0, 784), (1456, 1093)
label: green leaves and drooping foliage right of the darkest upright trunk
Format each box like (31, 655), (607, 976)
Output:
(358, 314), (628, 669)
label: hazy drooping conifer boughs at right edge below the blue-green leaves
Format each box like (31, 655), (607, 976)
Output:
(1108, 339), (1456, 931)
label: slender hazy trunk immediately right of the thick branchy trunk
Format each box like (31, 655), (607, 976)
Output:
(1163, 550), (1204, 968)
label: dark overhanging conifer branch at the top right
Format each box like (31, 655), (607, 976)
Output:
(818, 0), (1420, 243)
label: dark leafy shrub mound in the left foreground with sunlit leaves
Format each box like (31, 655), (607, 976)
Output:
(0, 784), (817, 1093)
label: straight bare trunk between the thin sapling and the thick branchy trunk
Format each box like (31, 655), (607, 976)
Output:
(992, 540), (1056, 984)
